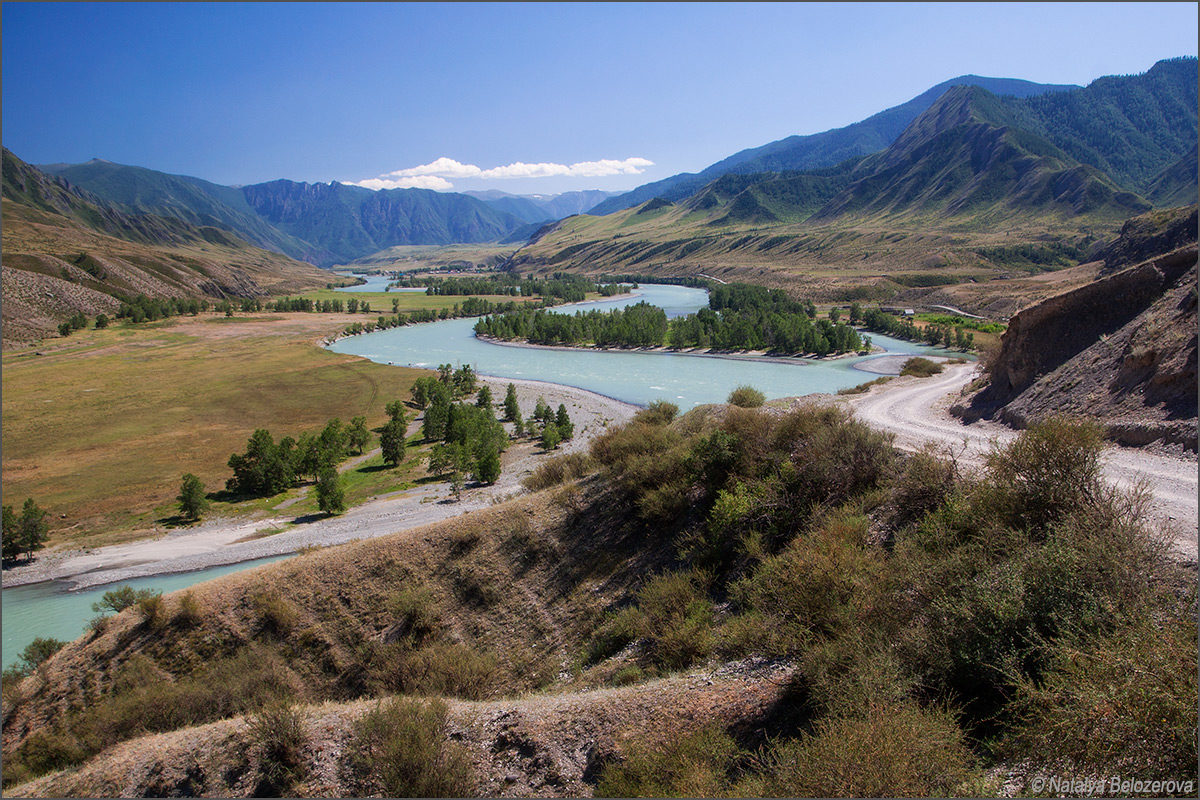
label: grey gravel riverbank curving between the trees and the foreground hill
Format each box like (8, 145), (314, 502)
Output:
(4, 378), (637, 589)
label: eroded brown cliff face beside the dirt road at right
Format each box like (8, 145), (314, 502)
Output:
(953, 206), (1196, 451)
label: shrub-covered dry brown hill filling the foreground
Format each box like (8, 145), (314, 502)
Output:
(4, 405), (1196, 796)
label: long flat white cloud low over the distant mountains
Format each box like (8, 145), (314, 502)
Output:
(352, 156), (654, 191)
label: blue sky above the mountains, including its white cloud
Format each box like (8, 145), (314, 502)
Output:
(2, 2), (1198, 193)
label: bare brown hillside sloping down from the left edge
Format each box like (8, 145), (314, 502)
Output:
(0, 150), (329, 347)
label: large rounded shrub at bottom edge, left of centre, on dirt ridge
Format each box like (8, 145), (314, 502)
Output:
(347, 698), (475, 798)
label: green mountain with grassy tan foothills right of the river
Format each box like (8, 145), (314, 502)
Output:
(512, 58), (1198, 297)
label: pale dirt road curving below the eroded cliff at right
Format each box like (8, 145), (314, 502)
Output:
(839, 363), (1198, 563)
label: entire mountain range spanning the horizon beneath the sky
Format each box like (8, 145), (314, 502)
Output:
(5, 58), (1196, 311)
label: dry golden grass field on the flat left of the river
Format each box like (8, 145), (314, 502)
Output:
(2, 309), (436, 546)
